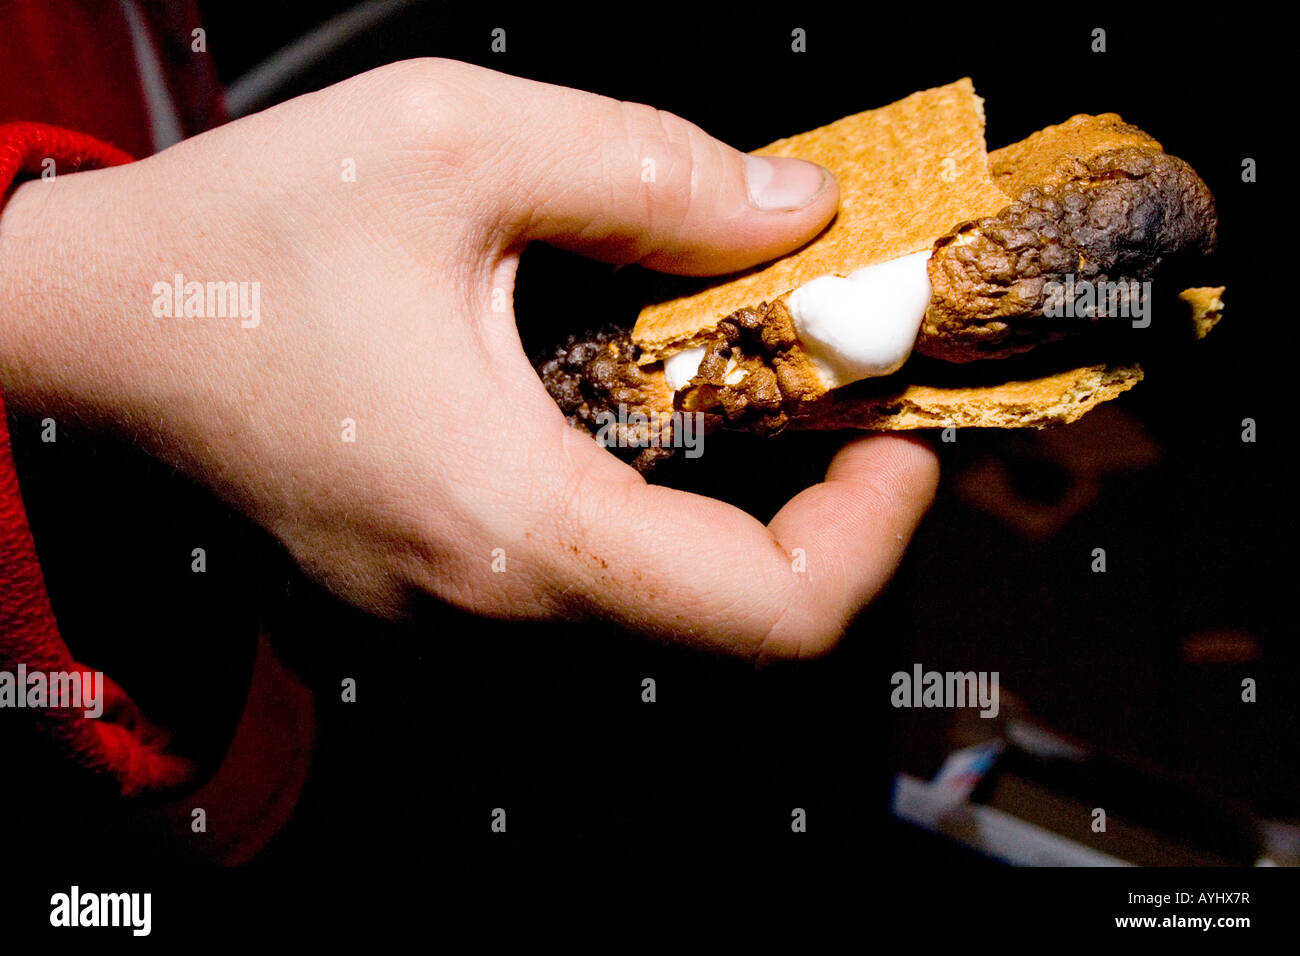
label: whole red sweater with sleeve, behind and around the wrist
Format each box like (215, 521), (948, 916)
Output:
(0, 0), (312, 862)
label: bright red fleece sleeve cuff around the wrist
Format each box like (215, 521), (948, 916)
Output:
(0, 122), (194, 796)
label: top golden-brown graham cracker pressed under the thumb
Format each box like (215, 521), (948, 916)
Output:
(632, 78), (1008, 364)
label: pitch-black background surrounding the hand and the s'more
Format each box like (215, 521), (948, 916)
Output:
(5, 1), (1300, 926)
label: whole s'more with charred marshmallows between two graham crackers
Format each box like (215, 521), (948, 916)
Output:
(538, 78), (1223, 468)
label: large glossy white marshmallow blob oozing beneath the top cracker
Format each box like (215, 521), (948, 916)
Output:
(787, 250), (931, 389)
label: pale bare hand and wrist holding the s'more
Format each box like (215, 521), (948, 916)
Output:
(0, 60), (937, 661)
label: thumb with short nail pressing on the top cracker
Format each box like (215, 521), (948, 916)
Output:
(462, 63), (840, 276)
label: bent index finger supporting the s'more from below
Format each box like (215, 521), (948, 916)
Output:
(543, 434), (939, 661)
